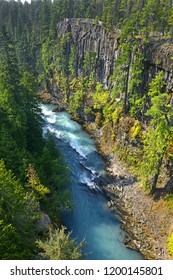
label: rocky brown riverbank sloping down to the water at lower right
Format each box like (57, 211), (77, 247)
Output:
(105, 156), (173, 260)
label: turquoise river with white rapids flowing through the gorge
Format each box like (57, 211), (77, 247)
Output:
(41, 105), (142, 260)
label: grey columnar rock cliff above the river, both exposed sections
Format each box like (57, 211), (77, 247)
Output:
(57, 19), (173, 92)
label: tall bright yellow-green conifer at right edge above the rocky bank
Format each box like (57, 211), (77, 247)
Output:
(141, 72), (173, 192)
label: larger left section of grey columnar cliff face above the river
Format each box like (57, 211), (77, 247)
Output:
(57, 19), (120, 87)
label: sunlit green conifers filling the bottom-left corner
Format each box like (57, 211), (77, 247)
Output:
(0, 160), (40, 259)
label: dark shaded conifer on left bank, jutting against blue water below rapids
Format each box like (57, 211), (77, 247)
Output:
(35, 134), (72, 221)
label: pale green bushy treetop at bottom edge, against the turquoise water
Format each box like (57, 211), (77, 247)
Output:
(37, 227), (84, 260)
